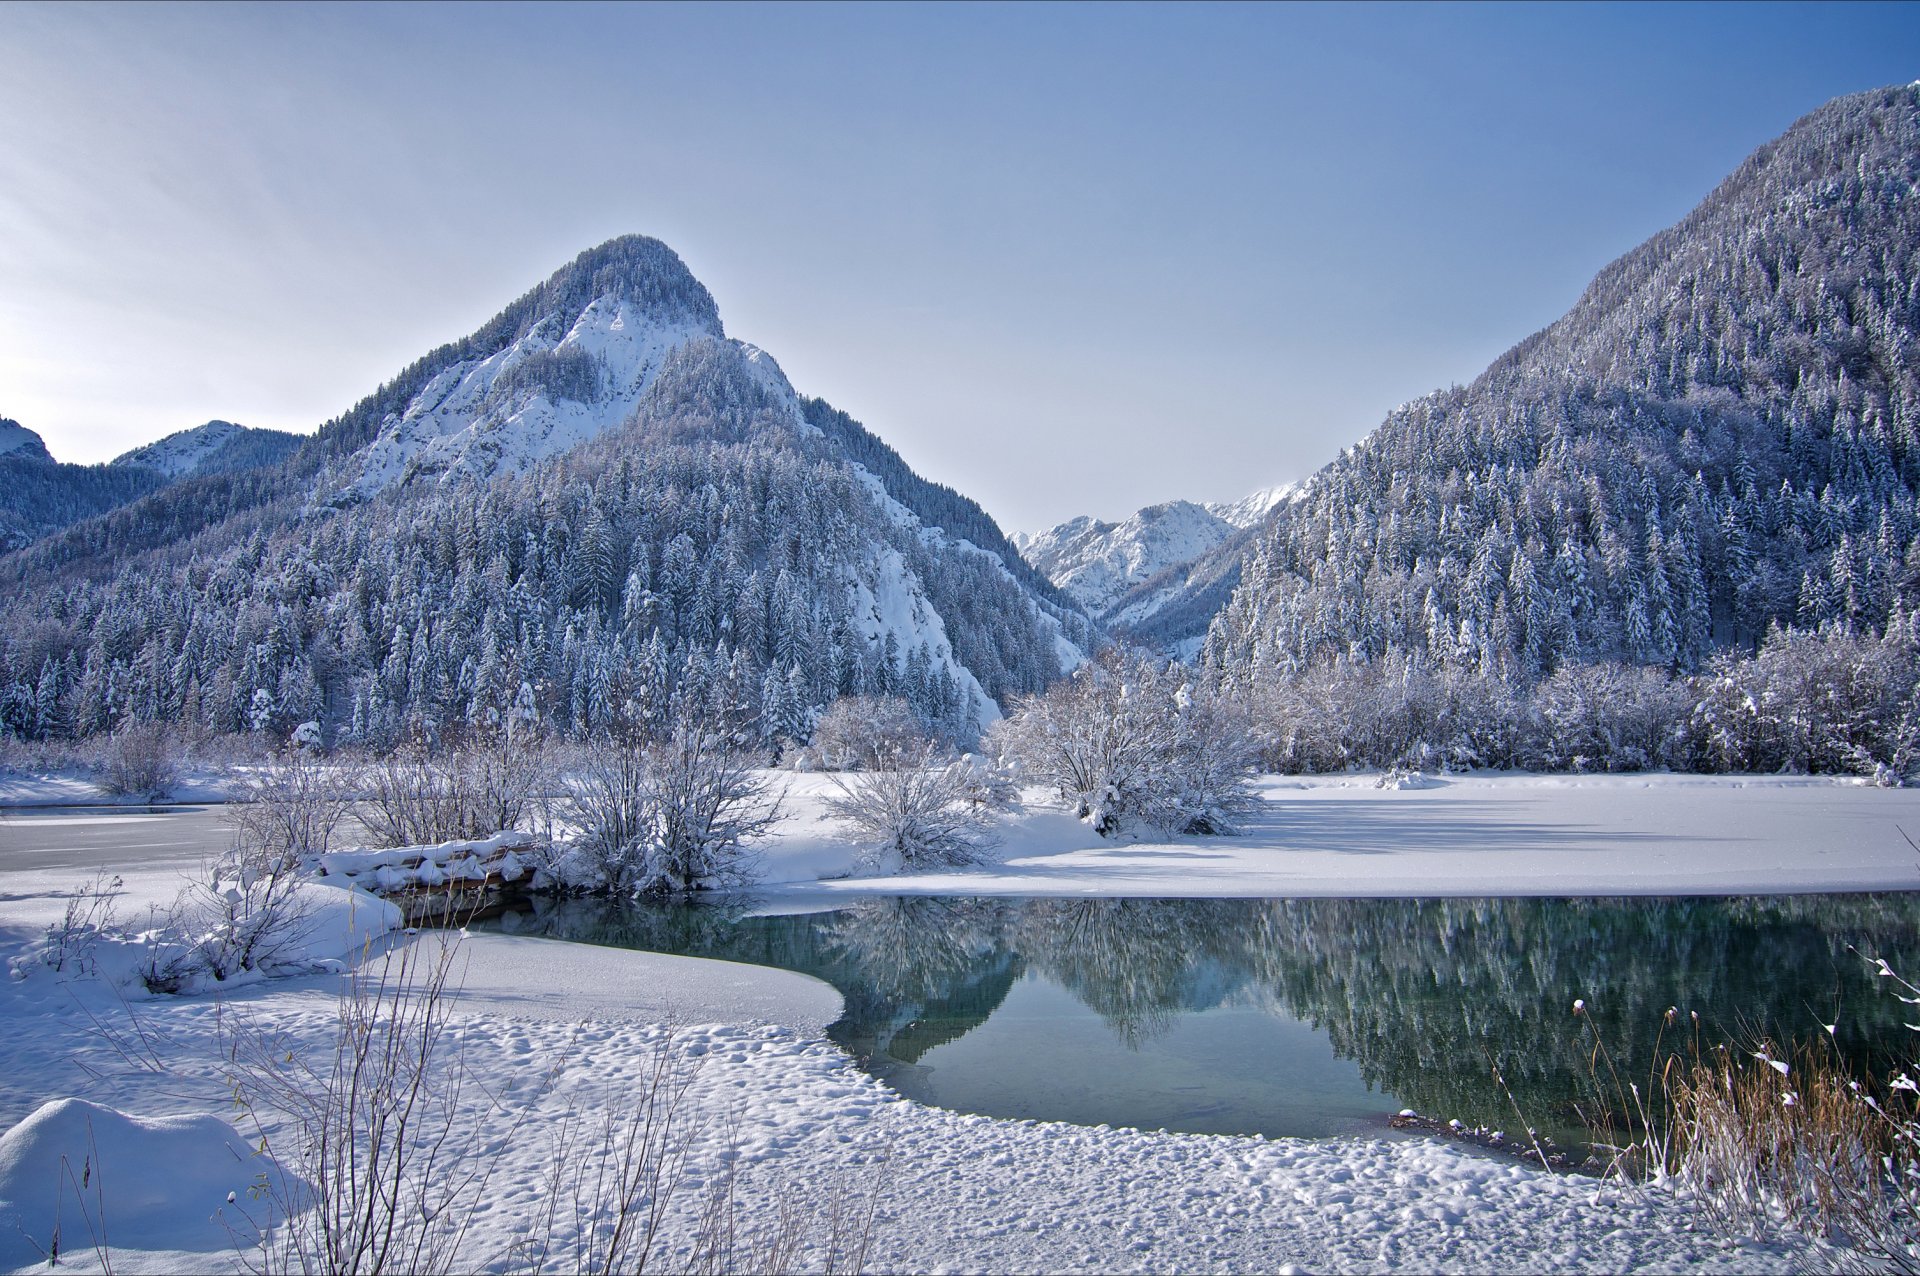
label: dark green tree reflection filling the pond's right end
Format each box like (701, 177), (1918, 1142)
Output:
(1248, 896), (1920, 1124)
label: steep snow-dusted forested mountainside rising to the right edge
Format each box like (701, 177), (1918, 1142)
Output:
(1206, 86), (1920, 681)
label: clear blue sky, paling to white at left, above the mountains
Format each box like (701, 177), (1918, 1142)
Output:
(0, 4), (1920, 530)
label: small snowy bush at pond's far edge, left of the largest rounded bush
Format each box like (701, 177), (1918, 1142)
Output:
(828, 746), (989, 869)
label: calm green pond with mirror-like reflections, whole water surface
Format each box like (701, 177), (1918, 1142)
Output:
(483, 894), (1920, 1142)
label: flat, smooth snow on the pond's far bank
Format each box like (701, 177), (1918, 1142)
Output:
(762, 773), (1920, 898)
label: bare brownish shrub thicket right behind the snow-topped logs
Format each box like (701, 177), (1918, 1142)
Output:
(359, 733), (547, 846)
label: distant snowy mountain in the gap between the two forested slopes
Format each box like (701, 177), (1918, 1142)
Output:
(1014, 484), (1296, 640)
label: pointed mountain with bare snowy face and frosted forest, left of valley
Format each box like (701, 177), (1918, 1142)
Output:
(0, 236), (1092, 746)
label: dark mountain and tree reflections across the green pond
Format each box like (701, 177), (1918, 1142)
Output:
(499, 894), (1920, 1126)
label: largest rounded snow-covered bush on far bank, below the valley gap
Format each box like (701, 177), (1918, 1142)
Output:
(989, 649), (1254, 837)
